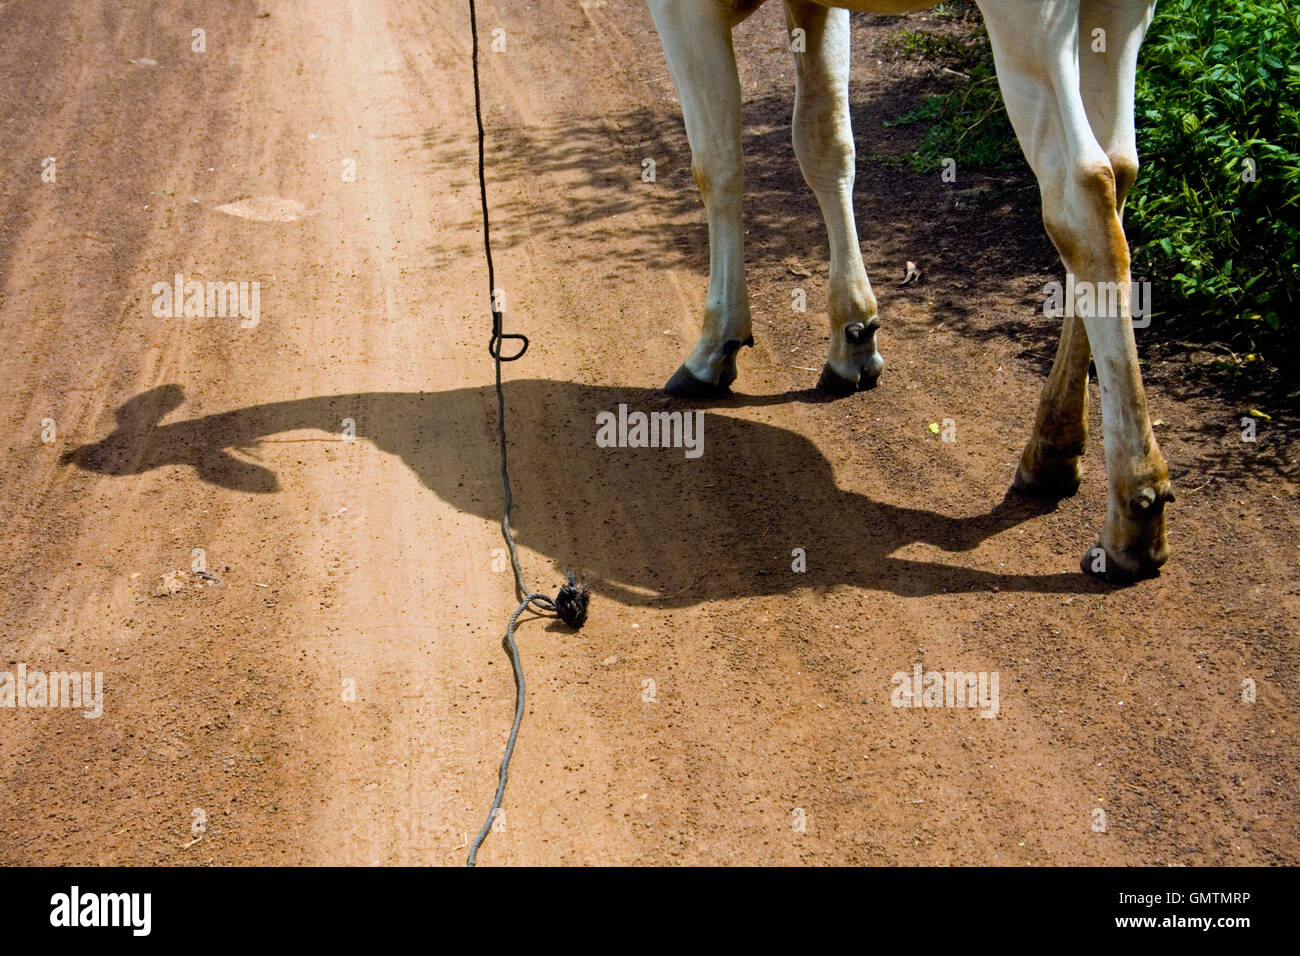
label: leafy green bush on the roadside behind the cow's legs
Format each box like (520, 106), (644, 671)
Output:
(894, 0), (1300, 350)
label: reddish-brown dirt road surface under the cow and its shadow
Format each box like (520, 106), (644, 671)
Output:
(0, 0), (1300, 865)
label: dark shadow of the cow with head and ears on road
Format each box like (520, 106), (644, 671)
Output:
(62, 380), (1099, 607)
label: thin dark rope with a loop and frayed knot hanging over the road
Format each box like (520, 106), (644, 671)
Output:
(465, 0), (588, 866)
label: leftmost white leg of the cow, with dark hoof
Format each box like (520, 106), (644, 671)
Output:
(650, 0), (754, 398)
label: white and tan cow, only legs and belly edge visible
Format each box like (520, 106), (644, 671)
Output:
(649, 0), (1174, 581)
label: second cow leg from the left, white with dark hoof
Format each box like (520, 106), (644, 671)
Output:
(785, 0), (884, 394)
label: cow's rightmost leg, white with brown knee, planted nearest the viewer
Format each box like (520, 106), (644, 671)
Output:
(980, 0), (1173, 580)
